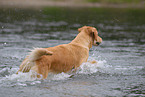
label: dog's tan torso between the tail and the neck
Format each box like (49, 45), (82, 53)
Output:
(45, 44), (89, 73)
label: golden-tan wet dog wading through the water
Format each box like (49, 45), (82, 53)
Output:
(17, 26), (102, 79)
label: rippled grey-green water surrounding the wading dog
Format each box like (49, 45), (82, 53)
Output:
(0, 8), (145, 97)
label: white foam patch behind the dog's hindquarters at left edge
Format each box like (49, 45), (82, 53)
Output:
(0, 68), (41, 87)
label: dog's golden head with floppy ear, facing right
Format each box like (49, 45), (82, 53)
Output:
(78, 26), (102, 46)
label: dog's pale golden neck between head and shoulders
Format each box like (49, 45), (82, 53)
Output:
(70, 31), (92, 50)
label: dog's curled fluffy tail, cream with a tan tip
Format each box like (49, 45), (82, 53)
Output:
(29, 48), (53, 62)
